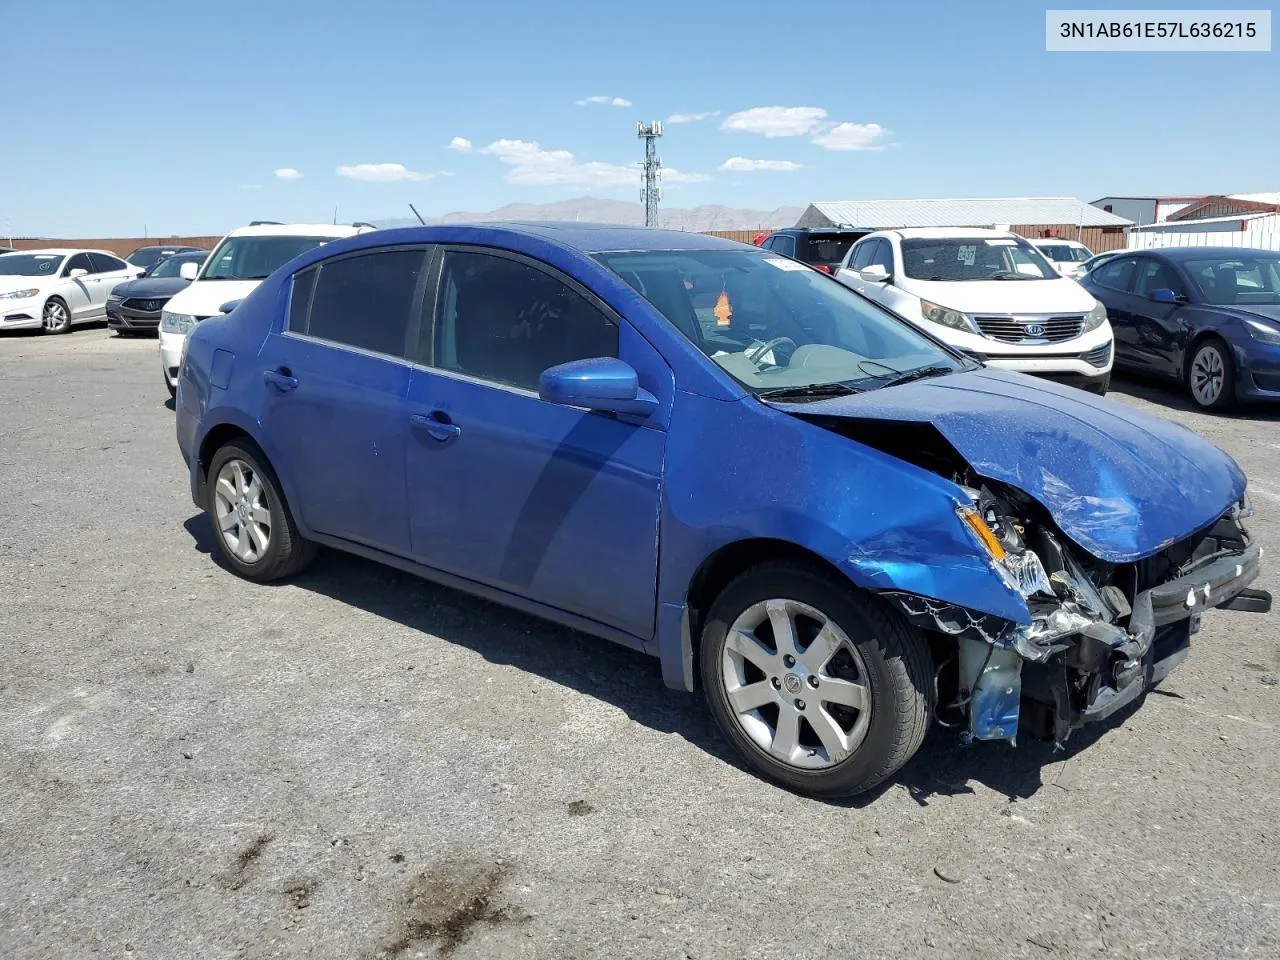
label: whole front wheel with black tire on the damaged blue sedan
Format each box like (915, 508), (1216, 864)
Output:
(699, 561), (934, 797)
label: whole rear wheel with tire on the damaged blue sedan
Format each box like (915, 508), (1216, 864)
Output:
(205, 438), (316, 584)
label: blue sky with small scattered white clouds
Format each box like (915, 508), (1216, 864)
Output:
(0, 0), (1280, 237)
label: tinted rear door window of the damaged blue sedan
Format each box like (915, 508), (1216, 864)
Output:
(291, 248), (425, 357)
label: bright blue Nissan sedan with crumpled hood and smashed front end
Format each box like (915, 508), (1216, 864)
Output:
(177, 224), (1270, 796)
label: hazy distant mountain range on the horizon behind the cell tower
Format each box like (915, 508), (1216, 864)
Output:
(374, 197), (804, 232)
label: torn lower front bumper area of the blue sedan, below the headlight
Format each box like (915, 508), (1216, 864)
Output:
(884, 537), (1271, 742)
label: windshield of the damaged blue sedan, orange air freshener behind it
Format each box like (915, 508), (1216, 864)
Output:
(596, 250), (968, 396)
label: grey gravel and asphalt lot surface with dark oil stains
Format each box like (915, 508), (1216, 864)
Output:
(0, 329), (1280, 960)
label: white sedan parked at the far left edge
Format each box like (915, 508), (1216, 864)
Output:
(0, 248), (143, 333)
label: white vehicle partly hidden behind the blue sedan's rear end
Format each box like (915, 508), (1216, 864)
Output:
(160, 223), (374, 396)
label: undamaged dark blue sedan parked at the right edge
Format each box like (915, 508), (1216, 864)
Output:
(1080, 247), (1280, 410)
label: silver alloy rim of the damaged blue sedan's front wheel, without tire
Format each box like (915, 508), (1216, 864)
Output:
(721, 598), (870, 771)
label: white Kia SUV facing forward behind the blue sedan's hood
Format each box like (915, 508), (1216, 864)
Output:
(836, 228), (1115, 394)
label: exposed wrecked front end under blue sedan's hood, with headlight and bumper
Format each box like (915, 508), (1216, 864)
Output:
(806, 417), (1271, 742)
